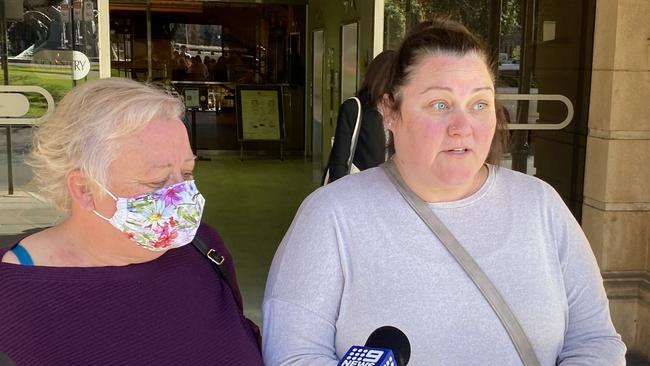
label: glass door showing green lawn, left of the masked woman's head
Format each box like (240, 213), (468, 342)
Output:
(0, 0), (99, 235)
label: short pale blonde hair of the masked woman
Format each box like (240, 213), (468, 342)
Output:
(28, 78), (185, 211)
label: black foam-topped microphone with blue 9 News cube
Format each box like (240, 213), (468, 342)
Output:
(338, 326), (411, 366)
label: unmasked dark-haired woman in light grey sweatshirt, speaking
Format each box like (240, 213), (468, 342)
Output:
(263, 20), (625, 366)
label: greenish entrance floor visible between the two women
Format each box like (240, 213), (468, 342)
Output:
(189, 152), (321, 321)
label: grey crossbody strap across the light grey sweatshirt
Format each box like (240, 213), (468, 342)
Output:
(382, 160), (539, 366)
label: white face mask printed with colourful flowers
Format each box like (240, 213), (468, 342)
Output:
(93, 180), (205, 251)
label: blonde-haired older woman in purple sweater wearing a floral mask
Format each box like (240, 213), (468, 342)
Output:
(0, 79), (262, 365)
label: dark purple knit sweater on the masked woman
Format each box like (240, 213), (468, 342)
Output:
(0, 225), (262, 366)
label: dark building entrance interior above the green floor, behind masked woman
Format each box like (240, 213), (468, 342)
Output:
(110, 0), (305, 154)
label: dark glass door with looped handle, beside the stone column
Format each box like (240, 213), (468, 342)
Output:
(498, 0), (595, 219)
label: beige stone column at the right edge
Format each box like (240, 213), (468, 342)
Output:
(582, 0), (650, 357)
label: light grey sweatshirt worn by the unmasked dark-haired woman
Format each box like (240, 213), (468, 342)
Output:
(263, 166), (625, 366)
